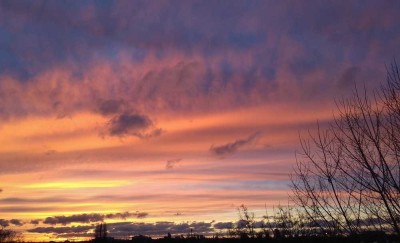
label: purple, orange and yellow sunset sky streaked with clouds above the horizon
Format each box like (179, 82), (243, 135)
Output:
(0, 0), (400, 241)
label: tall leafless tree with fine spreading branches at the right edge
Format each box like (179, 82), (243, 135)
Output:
(291, 63), (400, 235)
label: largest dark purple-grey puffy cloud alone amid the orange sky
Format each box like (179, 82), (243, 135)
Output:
(108, 112), (162, 138)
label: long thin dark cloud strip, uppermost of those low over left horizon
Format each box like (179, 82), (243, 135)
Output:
(43, 212), (148, 225)
